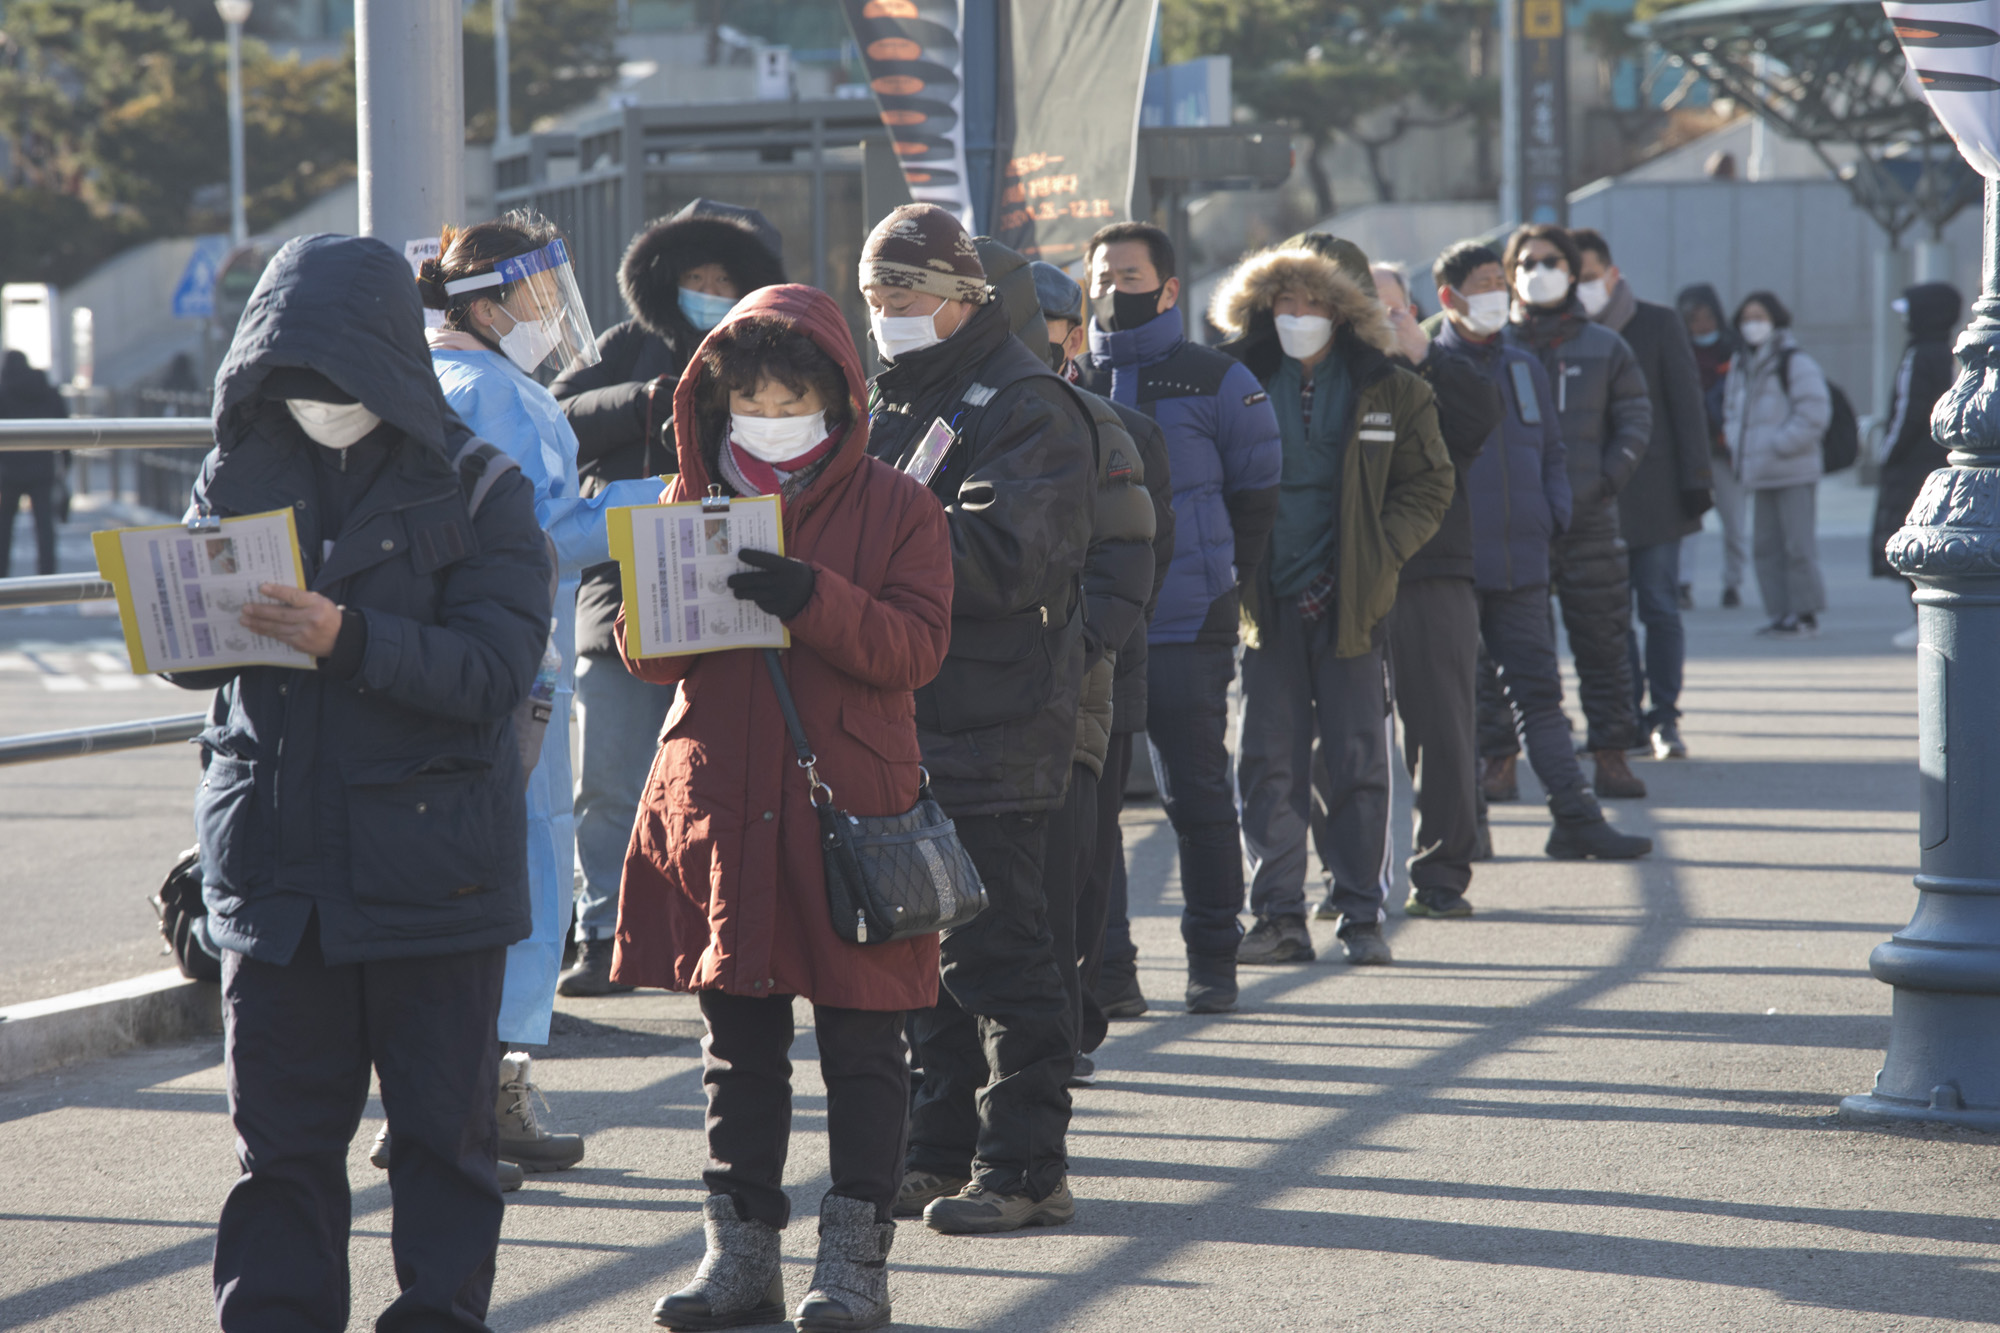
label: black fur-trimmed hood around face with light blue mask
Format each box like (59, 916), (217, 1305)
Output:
(618, 200), (784, 356)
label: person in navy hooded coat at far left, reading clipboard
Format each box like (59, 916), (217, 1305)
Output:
(174, 236), (552, 1331)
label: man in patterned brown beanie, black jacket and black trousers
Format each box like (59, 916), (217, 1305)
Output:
(860, 204), (1096, 1233)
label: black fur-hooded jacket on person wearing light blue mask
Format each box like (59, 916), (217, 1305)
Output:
(550, 198), (784, 656)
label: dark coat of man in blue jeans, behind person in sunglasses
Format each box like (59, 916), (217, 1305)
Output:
(1598, 278), (1716, 546)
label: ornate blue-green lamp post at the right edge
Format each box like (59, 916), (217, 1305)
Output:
(1840, 180), (2000, 1131)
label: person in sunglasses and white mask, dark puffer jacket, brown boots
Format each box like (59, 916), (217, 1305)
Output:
(1484, 222), (1652, 799)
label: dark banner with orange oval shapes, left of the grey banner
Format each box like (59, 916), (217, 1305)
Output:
(844, 0), (984, 230)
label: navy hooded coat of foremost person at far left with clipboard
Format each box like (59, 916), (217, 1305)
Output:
(174, 236), (550, 965)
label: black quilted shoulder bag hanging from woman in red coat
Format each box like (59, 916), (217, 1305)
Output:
(764, 648), (986, 945)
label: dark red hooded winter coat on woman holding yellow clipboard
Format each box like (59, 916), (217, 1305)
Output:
(612, 284), (952, 1009)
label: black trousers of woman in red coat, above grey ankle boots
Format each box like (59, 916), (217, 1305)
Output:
(700, 991), (910, 1227)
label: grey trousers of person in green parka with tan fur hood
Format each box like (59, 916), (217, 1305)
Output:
(1236, 596), (1390, 925)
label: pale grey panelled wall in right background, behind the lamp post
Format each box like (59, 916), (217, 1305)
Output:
(1570, 178), (1980, 414)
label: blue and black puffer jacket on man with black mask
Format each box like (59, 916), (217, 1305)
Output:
(1082, 310), (1284, 644)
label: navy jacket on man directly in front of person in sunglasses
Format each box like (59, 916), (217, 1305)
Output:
(1436, 320), (1570, 592)
